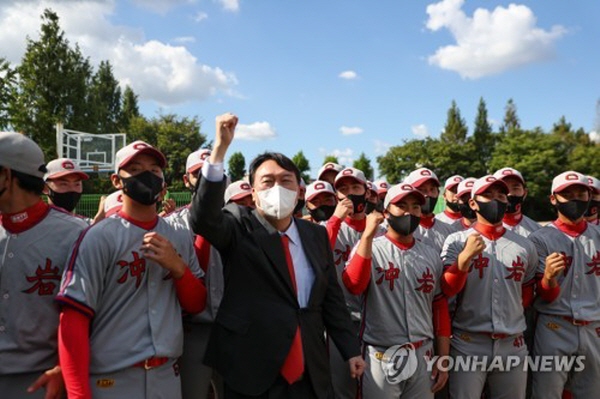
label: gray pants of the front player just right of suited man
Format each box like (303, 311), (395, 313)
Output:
(361, 341), (434, 399)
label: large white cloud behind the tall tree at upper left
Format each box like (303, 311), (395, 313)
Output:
(0, 0), (237, 106)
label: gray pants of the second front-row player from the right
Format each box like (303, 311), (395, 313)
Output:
(448, 330), (527, 399)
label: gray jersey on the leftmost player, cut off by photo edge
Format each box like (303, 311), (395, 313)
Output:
(0, 205), (86, 375)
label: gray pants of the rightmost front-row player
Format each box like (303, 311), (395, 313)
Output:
(532, 314), (600, 399)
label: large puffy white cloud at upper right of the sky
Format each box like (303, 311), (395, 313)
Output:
(426, 0), (567, 79)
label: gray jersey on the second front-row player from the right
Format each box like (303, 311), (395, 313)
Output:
(441, 227), (538, 335)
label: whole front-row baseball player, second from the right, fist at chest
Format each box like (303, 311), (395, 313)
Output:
(442, 175), (538, 399)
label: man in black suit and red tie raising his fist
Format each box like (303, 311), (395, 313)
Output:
(190, 114), (365, 399)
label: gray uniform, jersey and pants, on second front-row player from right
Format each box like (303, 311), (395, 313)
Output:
(442, 225), (538, 399)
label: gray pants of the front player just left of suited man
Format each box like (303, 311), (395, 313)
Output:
(90, 360), (181, 399)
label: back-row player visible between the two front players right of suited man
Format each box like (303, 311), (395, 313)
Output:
(404, 168), (454, 253)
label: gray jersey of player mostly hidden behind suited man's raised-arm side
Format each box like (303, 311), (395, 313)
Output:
(164, 205), (225, 323)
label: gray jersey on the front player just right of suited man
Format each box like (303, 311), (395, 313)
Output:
(361, 236), (443, 346)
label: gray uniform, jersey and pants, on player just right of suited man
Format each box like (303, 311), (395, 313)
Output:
(361, 236), (443, 398)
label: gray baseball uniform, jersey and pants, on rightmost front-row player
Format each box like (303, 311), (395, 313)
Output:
(529, 223), (600, 398)
